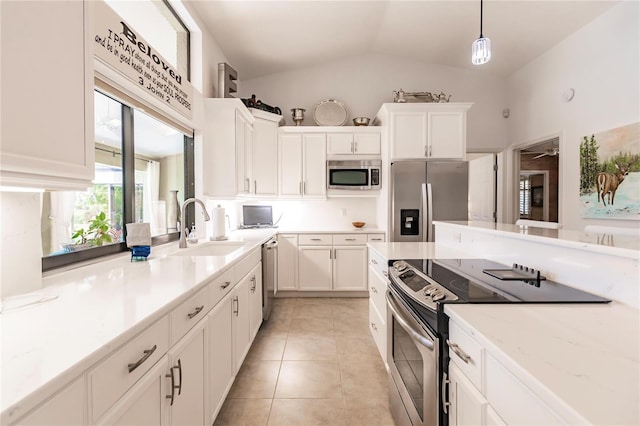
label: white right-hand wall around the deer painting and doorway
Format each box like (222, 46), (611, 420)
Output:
(507, 1), (640, 230)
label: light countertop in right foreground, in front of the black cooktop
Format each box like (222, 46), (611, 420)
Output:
(445, 302), (640, 425)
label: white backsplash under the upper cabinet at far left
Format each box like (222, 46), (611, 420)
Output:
(0, 192), (42, 297)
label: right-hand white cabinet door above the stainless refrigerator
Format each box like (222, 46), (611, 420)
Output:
(427, 111), (466, 159)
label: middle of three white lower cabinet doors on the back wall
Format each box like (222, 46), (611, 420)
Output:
(298, 246), (333, 291)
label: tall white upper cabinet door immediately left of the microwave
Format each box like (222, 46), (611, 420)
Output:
(302, 134), (327, 198)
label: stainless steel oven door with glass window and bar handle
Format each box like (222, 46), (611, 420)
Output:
(387, 288), (440, 426)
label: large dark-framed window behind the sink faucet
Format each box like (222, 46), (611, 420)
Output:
(42, 91), (194, 270)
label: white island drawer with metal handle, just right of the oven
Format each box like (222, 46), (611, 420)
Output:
(448, 321), (484, 391)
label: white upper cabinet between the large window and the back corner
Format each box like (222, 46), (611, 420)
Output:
(202, 98), (255, 199)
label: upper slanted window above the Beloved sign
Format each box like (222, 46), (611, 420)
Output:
(106, 0), (190, 80)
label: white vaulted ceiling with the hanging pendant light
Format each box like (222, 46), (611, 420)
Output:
(188, 0), (619, 80)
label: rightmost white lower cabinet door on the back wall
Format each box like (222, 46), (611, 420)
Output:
(333, 246), (367, 290)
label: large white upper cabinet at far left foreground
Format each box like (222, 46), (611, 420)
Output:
(0, 1), (94, 190)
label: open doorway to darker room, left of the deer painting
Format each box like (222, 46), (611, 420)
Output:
(516, 137), (560, 222)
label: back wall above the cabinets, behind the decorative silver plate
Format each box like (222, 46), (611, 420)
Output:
(238, 54), (508, 151)
